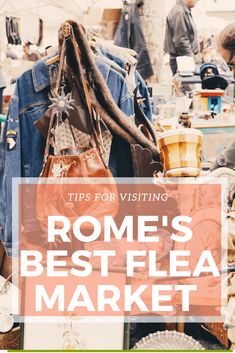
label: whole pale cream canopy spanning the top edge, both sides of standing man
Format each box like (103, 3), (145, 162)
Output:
(0, 0), (232, 47)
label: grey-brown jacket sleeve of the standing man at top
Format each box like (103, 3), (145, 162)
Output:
(172, 12), (194, 56)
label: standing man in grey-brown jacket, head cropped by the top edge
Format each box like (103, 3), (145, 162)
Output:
(164, 0), (199, 75)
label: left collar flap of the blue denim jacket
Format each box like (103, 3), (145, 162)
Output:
(32, 59), (50, 93)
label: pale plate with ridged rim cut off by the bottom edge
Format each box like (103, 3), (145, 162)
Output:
(133, 331), (205, 351)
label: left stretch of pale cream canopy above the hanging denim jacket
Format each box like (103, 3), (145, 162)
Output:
(0, 0), (122, 46)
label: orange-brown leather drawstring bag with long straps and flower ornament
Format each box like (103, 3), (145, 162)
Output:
(36, 33), (119, 231)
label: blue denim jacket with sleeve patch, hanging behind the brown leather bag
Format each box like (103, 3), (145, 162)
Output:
(0, 60), (134, 255)
